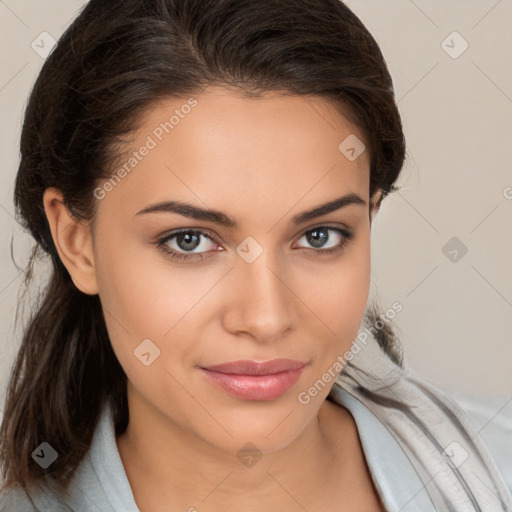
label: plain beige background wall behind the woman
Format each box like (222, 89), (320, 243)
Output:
(0, 0), (512, 411)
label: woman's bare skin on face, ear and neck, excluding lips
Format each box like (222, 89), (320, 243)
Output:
(44, 87), (382, 512)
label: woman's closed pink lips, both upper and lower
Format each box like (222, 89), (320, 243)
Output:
(199, 359), (308, 401)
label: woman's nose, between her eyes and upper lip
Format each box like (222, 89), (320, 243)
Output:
(224, 250), (297, 344)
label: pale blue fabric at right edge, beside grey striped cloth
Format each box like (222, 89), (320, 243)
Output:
(443, 389), (512, 493)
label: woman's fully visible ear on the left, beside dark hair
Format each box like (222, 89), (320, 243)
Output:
(43, 188), (98, 295)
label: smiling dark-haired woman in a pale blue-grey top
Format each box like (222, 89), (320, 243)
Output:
(0, 0), (512, 512)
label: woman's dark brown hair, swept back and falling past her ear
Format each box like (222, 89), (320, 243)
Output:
(0, 0), (405, 493)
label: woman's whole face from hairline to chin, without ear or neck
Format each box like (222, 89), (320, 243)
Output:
(93, 88), (376, 451)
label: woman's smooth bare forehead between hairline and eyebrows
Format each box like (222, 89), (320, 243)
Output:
(97, 88), (369, 220)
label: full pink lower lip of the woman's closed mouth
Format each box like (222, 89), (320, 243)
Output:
(200, 366), (305, 401)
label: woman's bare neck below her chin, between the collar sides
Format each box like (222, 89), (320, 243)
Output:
(117, 383), (358, 510)
